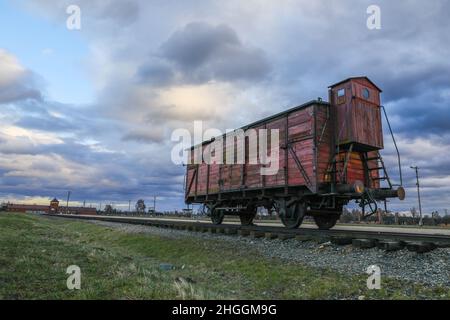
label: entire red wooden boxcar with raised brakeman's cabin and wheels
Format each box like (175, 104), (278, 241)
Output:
(185, 77), (404, 229)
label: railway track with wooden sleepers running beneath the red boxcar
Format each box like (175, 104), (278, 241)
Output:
(44, 214), (450, 253)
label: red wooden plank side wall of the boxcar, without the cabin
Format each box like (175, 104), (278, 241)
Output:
(186, 103), (330, 197)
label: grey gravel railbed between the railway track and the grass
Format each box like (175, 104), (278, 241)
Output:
(86, 221), (450, 288)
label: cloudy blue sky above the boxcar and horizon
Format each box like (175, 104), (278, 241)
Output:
(0, 0), (450, 212)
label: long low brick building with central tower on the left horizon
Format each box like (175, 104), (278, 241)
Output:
(6, 198), (97, 215)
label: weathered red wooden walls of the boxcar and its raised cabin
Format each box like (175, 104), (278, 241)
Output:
(185, 78), (383, 197)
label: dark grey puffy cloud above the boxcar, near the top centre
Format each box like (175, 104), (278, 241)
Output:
(137, 22), (271, 84)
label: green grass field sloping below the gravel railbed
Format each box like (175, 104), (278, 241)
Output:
(0, 213), (450, 299)
